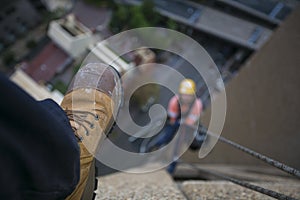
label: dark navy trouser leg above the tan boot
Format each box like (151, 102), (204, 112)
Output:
(0, 74), (80, 200)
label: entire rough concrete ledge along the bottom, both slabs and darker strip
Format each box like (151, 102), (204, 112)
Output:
(96, 165), (300, 200)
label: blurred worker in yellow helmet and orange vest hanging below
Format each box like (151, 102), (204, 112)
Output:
(148, 79), (202, 173)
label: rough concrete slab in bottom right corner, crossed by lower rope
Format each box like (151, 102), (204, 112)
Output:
(182, 181), (300, 200)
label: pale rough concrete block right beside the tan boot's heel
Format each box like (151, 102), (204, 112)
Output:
(96, 171), (186, 200)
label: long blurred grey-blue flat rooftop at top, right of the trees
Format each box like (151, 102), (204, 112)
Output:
(127, 0), (272, 50)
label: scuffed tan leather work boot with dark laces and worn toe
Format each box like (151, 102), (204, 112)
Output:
(61, 63), (122, 199)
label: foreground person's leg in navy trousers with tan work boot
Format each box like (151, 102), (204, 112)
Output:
(0, 64), (121, 200)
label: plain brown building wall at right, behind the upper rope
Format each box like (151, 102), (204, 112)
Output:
(184, 7), (300, 169)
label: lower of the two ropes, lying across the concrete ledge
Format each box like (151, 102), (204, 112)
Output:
(185, 163), (296, 200)
